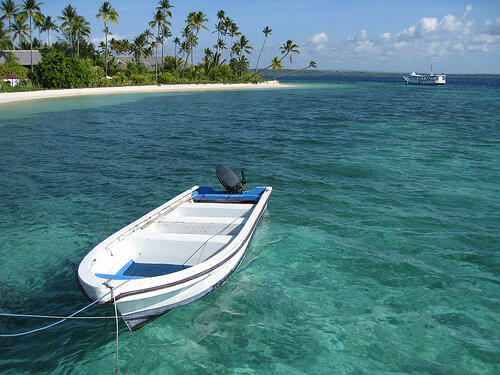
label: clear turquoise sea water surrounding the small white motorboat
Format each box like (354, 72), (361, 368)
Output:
(0, 80), (500, 374)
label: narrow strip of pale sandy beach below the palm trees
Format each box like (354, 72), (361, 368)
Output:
(0, 81), (289, 105)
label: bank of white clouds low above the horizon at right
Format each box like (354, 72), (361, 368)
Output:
(301, 5), (500, 73)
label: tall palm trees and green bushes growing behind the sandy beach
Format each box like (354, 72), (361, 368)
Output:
(0, 0), (299, 91)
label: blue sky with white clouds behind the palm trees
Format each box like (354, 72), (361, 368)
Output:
(26, 0), (500, 73)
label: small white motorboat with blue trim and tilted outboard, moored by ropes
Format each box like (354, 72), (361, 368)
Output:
(78, 166), (272, 331)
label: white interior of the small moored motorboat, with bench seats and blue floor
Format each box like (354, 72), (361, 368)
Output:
(91, 187), (265, 280)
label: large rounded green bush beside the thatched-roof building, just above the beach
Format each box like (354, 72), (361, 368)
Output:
(33, 52), (99, 89)
